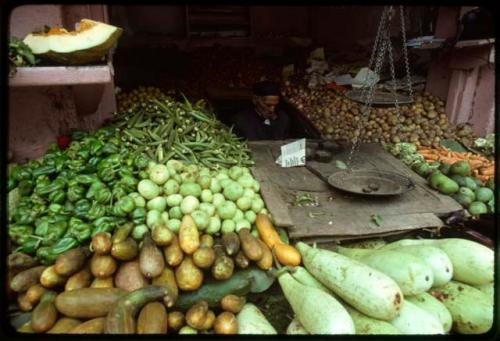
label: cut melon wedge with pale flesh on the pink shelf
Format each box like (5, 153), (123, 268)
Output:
(24, 19), (123, 65)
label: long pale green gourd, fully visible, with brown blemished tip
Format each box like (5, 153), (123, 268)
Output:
(297, 242), (403, 321)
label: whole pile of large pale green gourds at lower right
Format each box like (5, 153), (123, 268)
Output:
(279, 238), (494, 335)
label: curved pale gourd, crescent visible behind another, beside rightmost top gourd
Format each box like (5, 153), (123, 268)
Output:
(378, 245), (453, 287)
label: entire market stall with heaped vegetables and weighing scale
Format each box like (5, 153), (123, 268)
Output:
(2, 5), (497, 335)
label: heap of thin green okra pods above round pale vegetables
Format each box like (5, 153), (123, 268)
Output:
(114, 87), (253, 168)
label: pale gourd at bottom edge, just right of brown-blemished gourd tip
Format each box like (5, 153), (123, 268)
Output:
(390, 300), (444, 335)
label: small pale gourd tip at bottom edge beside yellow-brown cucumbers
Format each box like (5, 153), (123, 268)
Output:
(236, 303), (278, 335)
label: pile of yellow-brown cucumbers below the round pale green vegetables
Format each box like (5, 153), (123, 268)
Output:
(9, 215), (273, 334)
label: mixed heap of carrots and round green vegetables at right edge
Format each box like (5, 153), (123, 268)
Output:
(385, 142), (495, 216)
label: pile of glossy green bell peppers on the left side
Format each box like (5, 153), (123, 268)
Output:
(8, 126), (149, 264)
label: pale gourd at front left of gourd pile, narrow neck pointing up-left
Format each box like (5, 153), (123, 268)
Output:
(278, 273), (355, 334)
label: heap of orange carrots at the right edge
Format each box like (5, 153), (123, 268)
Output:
(417, 147), (495, 182)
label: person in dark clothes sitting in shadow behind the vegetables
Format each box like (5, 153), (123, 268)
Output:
(232, 81), (290, 140)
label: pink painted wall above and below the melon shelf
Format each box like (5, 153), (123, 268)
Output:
(9, 5), (116, 162)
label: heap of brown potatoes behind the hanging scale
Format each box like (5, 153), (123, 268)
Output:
(284, 82), (473, 147)
